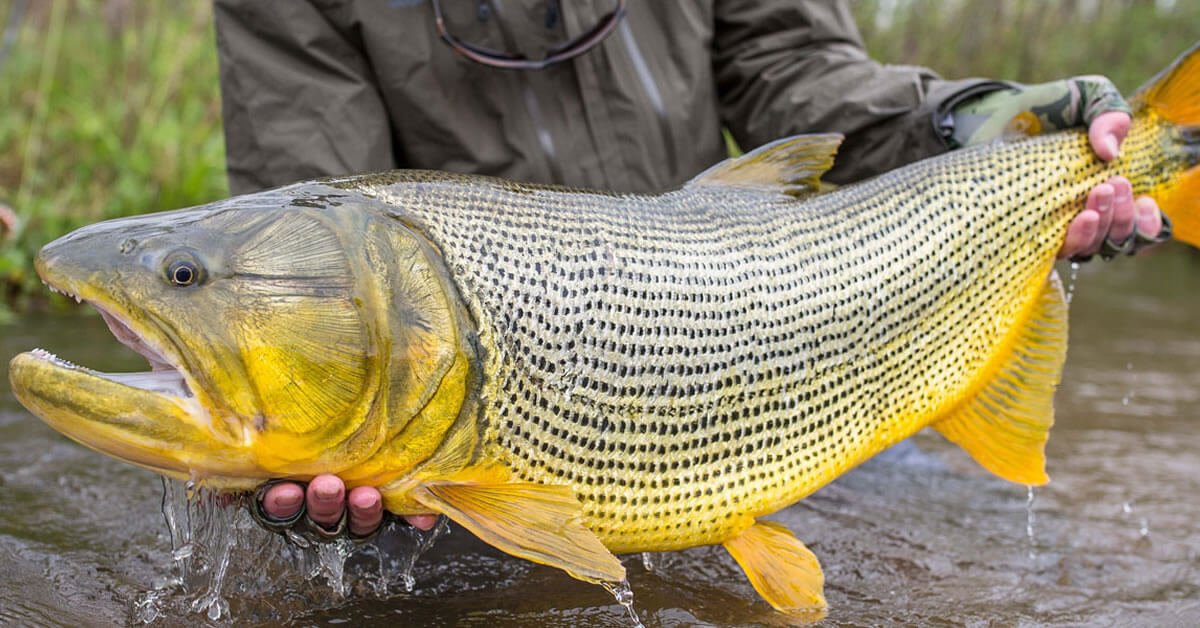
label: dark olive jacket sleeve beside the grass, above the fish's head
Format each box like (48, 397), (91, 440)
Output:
(214, 0), (395, 193)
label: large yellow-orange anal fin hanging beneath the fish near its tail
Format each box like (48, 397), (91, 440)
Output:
(934, 274), (1067, 485)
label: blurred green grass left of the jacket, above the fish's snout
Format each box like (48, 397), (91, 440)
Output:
(0, 0), (226, 309)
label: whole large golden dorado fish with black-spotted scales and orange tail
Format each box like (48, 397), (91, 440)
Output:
(11, 49), (1200, 612)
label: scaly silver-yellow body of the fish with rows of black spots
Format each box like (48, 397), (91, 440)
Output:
(337, 125), (1141, 552)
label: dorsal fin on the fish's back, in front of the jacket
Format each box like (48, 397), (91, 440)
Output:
(688, 133), (842, 196)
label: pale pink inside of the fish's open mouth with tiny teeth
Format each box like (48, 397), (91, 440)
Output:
(30, 283), (194, 397)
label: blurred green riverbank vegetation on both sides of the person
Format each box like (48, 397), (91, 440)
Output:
(0, 0), (1200, 311)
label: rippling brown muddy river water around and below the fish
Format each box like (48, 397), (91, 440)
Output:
(0, 250), (1200, 627)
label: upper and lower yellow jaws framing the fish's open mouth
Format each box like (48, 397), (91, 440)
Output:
(8, 229), (263, 489)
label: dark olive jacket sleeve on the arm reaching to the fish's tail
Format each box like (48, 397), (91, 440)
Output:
(713, 0), (1003, 183)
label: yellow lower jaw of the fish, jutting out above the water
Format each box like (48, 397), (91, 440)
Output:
(8, 349), (262, 489)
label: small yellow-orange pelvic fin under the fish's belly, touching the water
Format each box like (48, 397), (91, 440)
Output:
(724, 521), (827, 621)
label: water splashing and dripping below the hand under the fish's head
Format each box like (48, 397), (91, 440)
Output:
(128, 480), (449, 624)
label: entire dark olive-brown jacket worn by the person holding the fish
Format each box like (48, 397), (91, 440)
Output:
(216, 0), (995, 193)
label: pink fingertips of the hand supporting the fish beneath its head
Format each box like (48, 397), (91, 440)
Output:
(259, 473), (438, 537)
